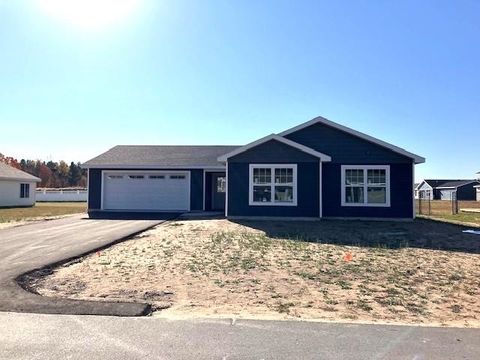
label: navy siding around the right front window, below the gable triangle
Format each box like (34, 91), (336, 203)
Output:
(322, 163), (413, 219)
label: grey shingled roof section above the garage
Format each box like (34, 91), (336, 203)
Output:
(82, 145), (238, 169)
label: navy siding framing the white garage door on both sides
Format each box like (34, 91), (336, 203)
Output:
(88, 169), (203, 211)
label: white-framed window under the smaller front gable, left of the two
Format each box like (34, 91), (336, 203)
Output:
(248, 164), (297, 206)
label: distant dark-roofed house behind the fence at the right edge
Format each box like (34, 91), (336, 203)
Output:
(416, 179), (480, 200)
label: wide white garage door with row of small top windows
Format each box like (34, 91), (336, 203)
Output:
(103, 172), (190, 211)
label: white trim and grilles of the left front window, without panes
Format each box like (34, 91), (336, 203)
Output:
(248, 164), (298, 206)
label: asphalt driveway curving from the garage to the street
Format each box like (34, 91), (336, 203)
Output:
(0, 214), (173, 316)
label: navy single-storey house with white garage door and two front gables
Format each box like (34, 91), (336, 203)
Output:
(82, 117), (425, 219)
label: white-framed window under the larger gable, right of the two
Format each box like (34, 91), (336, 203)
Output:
(341, 165), (390, 207)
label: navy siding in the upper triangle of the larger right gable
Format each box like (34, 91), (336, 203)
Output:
(285, 123), (412, 164)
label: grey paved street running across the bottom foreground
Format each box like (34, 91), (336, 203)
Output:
(0, 313), (480, 360)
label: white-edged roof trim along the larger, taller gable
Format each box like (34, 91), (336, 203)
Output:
(278, 116), (425, 164)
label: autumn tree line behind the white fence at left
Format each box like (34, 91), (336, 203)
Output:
(0, 153), (87, 188)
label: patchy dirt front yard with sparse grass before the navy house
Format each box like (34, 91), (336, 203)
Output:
(30, 220), (480, 327)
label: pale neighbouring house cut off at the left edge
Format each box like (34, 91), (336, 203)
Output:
(0, 162), (41, 207)
